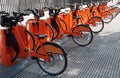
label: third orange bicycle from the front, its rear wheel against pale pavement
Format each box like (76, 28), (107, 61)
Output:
(76, 4), (104, 33)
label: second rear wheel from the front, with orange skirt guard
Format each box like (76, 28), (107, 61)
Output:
(72, 25), (93, 46)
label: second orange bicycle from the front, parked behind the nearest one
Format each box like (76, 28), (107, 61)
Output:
(45, 7), (93, 46)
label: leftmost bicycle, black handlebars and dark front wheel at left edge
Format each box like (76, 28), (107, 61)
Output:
(0, 11), (20, 62)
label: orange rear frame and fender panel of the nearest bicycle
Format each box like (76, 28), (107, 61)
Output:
(30, 40), (63, 62)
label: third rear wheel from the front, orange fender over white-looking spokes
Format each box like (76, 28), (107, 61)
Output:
(88, 17), (104, 33)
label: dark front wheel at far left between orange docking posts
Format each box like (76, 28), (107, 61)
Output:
(6, 33), (20, 62)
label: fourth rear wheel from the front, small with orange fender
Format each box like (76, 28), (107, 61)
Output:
(101, 11), (113, 23)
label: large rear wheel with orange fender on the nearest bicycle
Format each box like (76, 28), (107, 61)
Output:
(36, 42), (67, 75)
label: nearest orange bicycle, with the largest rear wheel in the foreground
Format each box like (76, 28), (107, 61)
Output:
(2, 10), (67, 75)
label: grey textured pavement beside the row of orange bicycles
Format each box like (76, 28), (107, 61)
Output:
(0, 8), (120, 78)
